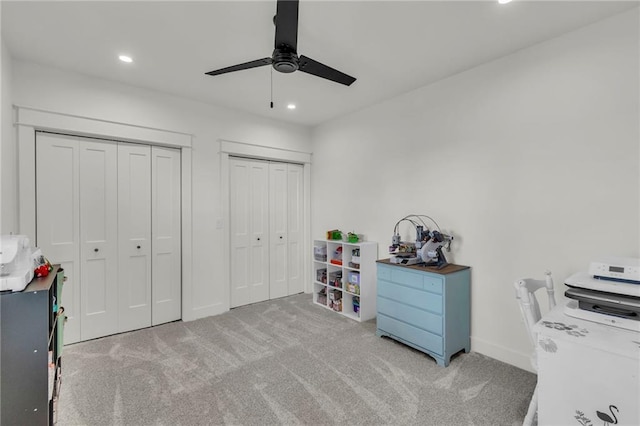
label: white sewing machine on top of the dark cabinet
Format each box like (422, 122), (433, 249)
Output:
(0, 235), (41, 291)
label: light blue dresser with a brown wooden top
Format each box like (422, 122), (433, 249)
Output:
(376, 259), (471, 367)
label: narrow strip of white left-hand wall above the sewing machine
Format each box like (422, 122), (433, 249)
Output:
(0, 34), (18, 235)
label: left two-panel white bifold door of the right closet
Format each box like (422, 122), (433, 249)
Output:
(229, 158), (269, 308)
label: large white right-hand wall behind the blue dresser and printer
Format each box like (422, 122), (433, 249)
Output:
(312, 9), (640, 369)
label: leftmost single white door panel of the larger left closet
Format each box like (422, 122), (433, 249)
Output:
(34, 133), (81, 344)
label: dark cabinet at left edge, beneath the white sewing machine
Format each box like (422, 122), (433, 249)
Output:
(0, 265), (65, 426)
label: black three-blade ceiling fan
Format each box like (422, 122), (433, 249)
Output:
(205, 0), (356, 86)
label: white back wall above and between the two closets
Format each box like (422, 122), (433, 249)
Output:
(13, 59), (310, 318)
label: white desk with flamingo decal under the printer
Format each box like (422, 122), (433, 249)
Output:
(535, 306), (640, 426)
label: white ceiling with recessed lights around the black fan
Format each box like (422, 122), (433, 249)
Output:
(0, 0), (638, 125)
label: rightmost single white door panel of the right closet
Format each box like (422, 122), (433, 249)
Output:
(287, 164), (306, 295)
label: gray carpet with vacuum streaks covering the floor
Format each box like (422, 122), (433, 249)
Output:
(58, 294), (536, 426)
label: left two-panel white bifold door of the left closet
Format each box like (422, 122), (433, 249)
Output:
(36, 133), (118, 343)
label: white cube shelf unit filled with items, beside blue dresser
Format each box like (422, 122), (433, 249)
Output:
(313, 240), (378, 321)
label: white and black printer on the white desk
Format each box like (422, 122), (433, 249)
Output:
(564, 258), (640, 332)
